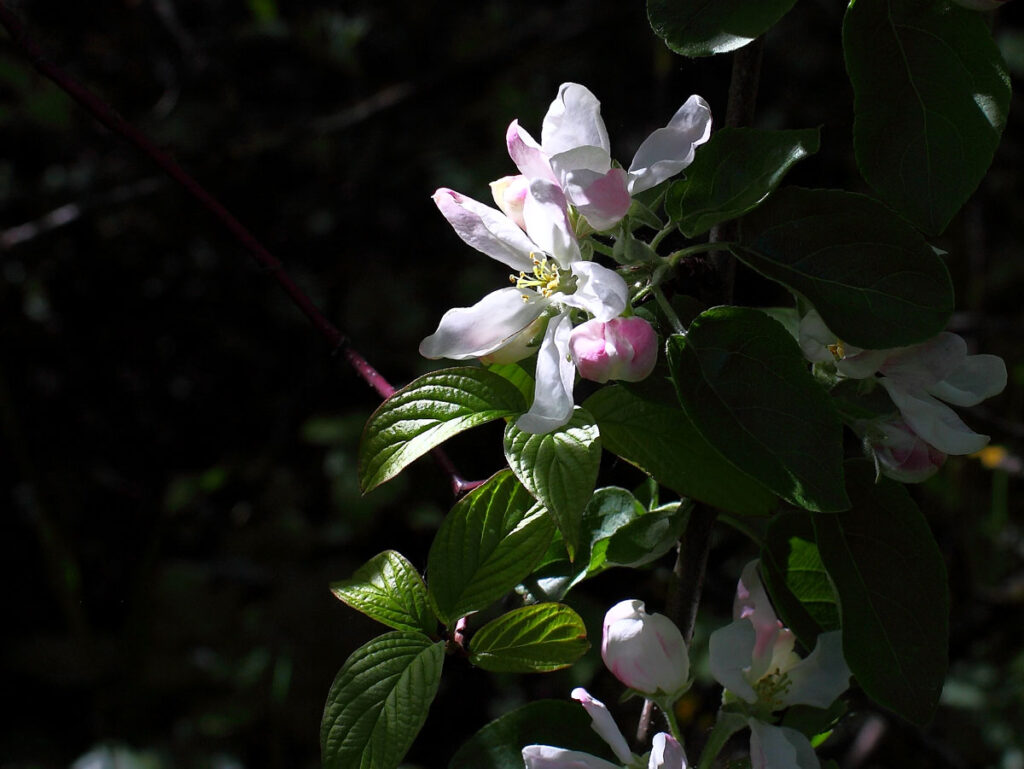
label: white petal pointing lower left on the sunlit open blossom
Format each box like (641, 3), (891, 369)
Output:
(420, 287), (550, 360)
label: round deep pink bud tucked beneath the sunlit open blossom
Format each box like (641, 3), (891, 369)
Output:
(569, 317), (657, 384)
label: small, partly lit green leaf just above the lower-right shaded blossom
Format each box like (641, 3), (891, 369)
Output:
(761, 512), (840, 649)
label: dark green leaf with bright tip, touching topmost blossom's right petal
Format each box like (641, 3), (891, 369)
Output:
(665, 128), (820, 238)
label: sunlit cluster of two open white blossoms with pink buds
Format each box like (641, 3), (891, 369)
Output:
(420, 83), (711, 433)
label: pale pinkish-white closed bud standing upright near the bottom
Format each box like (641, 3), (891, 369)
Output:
(601, 600), (690, 696)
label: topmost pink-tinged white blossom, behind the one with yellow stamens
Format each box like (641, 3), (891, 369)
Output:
(506, 83), (711, 230)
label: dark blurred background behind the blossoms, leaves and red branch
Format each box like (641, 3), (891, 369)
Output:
(0, 0), (1024, 769)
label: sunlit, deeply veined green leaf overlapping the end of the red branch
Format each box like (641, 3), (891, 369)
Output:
(358, 367), (526, 492)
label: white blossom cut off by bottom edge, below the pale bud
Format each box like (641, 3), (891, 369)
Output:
(522, 688), (687, 769)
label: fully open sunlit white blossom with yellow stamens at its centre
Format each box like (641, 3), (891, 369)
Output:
(420, 179), (629, 433)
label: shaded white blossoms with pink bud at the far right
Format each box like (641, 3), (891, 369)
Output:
(800, 310), (1007, 482)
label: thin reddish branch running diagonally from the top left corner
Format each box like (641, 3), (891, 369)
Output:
(0, 0), (476, 495)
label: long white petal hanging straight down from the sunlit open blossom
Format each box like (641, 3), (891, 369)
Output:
(515, 314), (575, 434)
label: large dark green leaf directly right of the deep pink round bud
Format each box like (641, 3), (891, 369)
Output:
(668, 307), (850, 511)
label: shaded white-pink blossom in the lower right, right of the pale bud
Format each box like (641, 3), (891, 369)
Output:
(710, 561), (850, 769)
